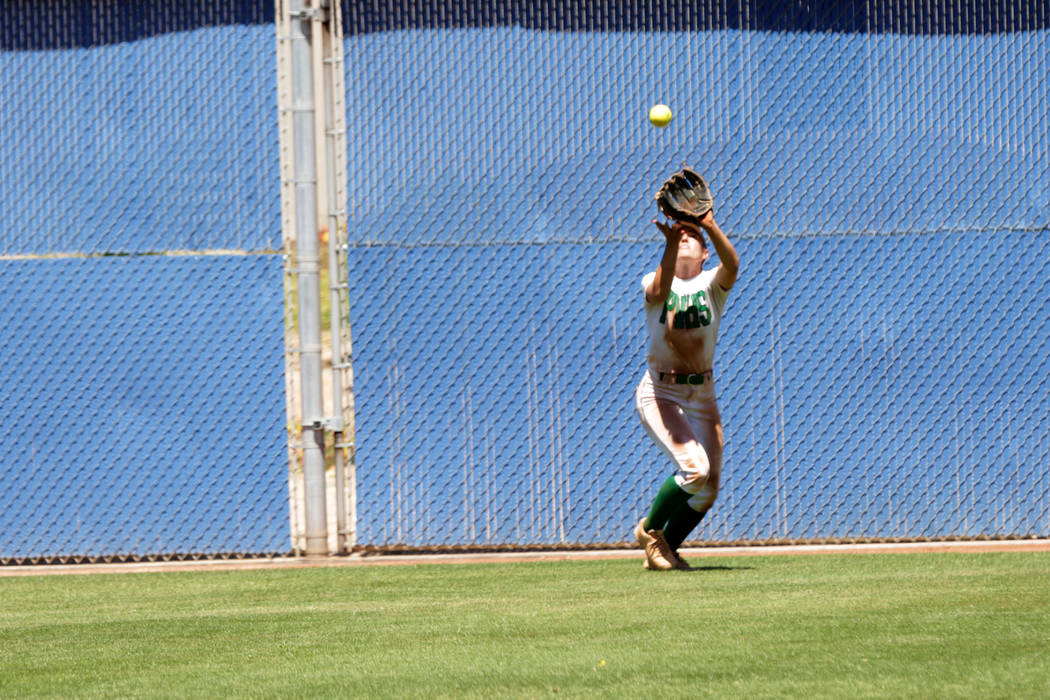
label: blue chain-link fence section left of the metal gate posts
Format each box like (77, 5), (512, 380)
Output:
(0, 0), (289, 561)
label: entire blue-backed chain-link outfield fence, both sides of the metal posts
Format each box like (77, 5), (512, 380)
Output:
(0, 0), (1050, 563)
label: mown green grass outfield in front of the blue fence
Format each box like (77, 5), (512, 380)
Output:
(0, 553), (1050, 698)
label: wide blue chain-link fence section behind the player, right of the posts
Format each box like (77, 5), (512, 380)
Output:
(343, 1), (1050, 548)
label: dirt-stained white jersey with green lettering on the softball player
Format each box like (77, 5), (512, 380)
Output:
(642, 269), (729, 373)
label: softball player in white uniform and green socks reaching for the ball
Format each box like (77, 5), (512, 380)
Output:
(634, 169), (739, 570)
